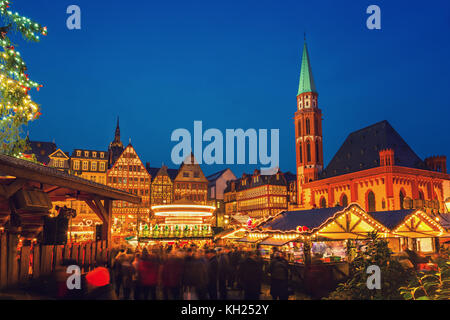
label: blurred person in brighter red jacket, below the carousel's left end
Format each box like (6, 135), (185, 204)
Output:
(138, 248), (161, 300)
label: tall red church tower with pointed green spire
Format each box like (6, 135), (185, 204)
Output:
(294, 41), (323, 205)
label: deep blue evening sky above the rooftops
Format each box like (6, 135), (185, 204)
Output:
(12, 0), (450, 175)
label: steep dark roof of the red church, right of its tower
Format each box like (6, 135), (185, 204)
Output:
(320, 120), (426, 178)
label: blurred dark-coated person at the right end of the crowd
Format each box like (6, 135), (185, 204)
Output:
(269, 252), (289, 300)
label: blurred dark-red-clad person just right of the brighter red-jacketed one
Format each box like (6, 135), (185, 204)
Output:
(161, 251), (183, 300)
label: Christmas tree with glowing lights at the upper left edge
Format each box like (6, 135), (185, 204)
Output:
(0, 0), (47, 157)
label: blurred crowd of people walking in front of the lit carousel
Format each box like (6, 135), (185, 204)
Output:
(111, 245), (289, 300)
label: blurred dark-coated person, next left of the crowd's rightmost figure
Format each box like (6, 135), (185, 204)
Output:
(239, 251), (262, 300)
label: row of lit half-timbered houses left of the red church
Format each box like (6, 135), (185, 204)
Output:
(29, 121), (297, 235)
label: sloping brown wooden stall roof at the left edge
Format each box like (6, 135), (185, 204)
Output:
(0, 154), (141, 204)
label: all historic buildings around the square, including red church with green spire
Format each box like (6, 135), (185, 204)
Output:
(25, 43), (450, 238)
